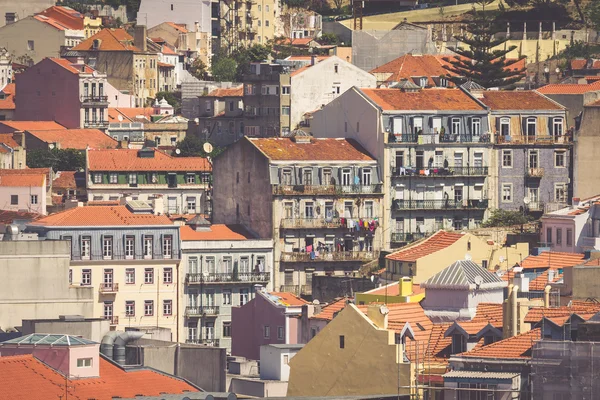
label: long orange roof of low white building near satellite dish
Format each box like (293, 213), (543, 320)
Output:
(88, 149), (211, 172)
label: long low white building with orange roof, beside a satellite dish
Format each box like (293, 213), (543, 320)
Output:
(86, 148), (211, 214)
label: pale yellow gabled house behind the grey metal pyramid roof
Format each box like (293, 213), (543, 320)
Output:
(384, 230), (529, 283)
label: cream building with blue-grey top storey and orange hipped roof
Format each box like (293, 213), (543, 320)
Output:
(27, 202), (181, 339)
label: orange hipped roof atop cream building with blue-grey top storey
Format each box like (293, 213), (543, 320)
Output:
(32, 206), (173, 226)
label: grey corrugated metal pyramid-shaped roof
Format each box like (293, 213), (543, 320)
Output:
(421, 260), (506, 289)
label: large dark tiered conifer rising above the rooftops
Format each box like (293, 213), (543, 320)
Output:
(444, 0), (525, 88)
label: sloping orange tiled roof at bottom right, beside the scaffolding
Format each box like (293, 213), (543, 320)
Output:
(458, 328), (542, 359)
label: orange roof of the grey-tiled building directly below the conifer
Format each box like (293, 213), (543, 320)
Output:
(480, 90), (565, 111)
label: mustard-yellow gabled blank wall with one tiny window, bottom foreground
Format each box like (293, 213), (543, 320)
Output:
(287, 304), (413, 396)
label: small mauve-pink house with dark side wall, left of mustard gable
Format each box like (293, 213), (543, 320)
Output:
(231, 290), (308, 360)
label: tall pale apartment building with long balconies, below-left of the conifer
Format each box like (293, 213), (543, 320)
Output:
(311, 85), (493, 247)
